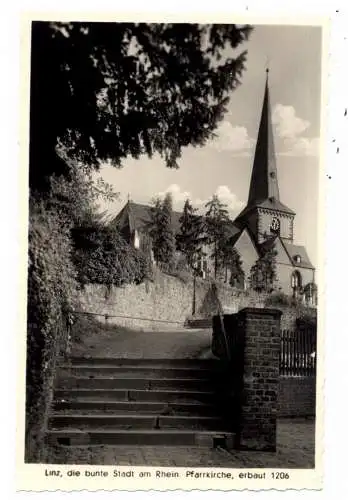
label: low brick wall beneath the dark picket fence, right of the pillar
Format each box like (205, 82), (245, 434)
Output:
(278, 377), (316, 417)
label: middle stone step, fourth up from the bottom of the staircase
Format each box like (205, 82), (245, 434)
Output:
(54, 388), (217, 403)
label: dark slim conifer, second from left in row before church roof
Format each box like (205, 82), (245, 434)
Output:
(176, 199), (203, 269)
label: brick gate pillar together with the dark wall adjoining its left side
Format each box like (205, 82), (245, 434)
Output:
(212, 308), (281, 451)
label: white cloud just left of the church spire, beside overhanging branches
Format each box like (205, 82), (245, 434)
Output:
(210, 120), (255, 153)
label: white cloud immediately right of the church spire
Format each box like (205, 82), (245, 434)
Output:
(272, 104), (310, 138)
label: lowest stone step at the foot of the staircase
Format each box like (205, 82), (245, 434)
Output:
(47, 429), (235, 448)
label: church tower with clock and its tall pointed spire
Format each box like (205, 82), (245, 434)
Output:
(235, 69), (295, 244)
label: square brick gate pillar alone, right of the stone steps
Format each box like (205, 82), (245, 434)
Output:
(237, 308), (282, 451)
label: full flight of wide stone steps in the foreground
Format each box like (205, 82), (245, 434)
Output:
(48, 358), (235, 448)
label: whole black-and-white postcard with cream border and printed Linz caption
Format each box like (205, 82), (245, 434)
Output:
(17, 14), (327, 491)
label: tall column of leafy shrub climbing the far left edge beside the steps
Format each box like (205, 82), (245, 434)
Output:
(25, 204), (76, 462)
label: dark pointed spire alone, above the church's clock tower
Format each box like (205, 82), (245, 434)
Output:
(248, 68), (279, 206)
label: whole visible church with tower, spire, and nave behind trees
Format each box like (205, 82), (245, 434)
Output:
(111, 71), (315, 304)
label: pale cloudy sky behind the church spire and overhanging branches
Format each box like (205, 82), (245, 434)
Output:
(96, 26), (321, 264)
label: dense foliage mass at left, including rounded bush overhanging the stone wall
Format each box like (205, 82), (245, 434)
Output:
(26, 166), (147, 462)
